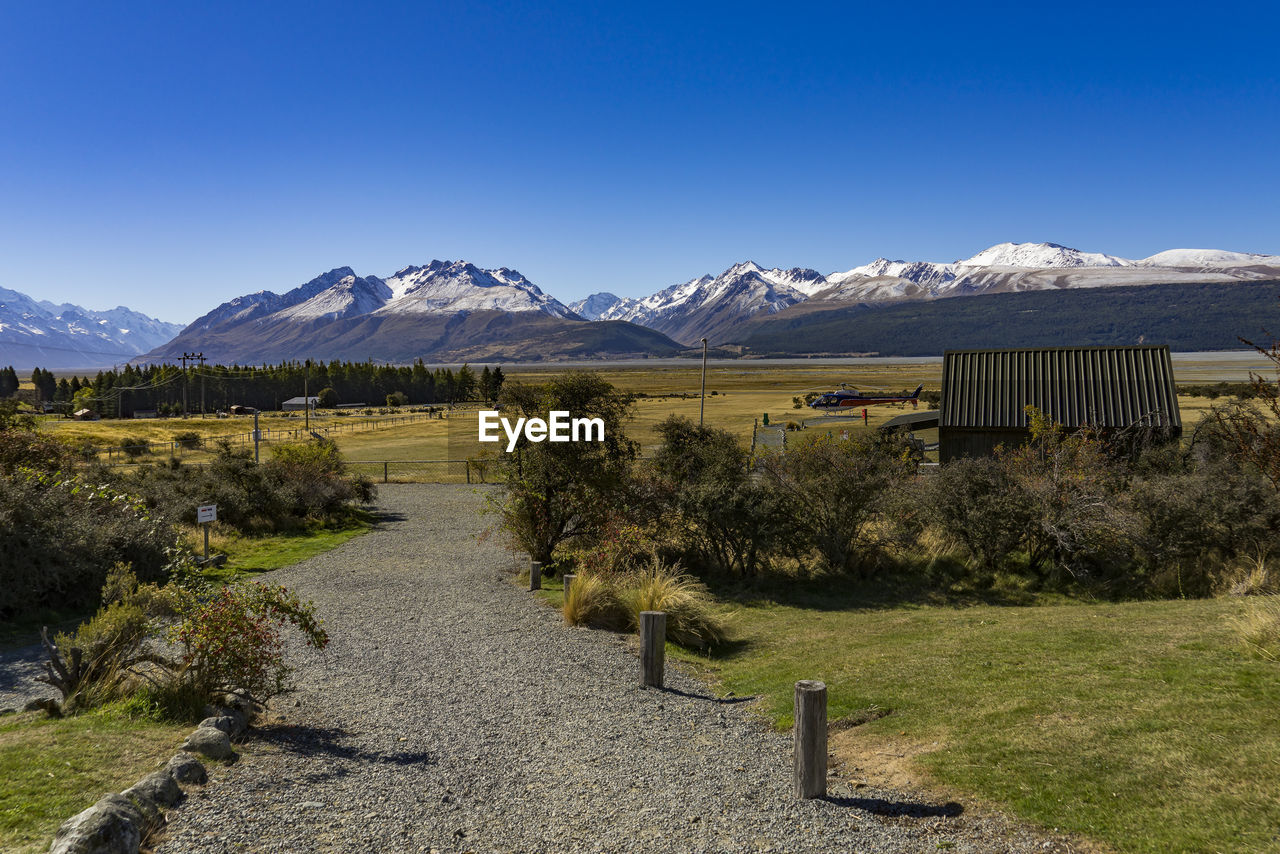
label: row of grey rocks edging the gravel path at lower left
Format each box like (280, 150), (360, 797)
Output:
(49, 694), (257, 854)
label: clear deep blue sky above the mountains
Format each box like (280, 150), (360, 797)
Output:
(0, 1), (1280, 321)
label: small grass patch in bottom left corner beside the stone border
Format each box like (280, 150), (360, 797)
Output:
(0, 707), (191, 854)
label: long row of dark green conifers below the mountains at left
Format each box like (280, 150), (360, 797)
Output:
(0, 360), (506, 417)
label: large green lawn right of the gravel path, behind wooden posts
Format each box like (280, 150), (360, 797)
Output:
(673, 599), (1280, 853)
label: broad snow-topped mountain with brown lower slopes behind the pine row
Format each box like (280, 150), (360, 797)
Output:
(136, 261), (678, 362)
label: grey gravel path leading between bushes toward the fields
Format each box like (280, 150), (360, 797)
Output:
(156, 485), (1070, 853)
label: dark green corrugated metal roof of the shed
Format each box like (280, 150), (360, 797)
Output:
(938, 346), (1181, 431)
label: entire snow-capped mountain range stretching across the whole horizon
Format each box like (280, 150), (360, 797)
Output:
(0, 243), (1280, 367)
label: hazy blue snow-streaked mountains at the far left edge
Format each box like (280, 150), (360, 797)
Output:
(0, 288), (182, 370)
